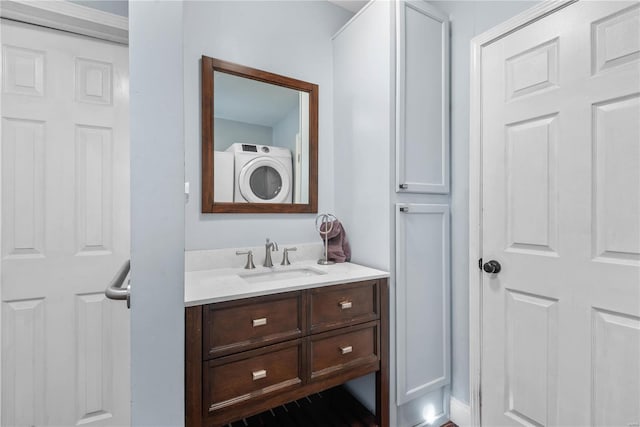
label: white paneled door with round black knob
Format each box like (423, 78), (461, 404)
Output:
(481, 1), (640, 427)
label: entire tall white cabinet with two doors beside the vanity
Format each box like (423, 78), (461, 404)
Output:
(334, 0), (451, 426)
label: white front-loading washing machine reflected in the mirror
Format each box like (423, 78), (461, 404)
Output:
(227, 143), (293, 203)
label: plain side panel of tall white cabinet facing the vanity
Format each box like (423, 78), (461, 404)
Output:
(334, 1), (393, 271)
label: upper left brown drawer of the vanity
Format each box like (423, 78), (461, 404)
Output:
(202, 292), (305, 359)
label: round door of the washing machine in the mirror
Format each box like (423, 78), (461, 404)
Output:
(238, 157), (291, 203)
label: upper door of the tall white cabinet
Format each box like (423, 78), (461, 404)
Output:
(396, 0), (449, 194)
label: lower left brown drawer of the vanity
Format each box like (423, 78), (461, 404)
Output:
(203, 340), (303, 413)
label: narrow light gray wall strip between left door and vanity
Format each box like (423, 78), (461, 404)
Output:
(129, 1), (184, 427)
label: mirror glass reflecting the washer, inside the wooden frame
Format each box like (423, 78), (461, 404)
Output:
(213, 71), (309, 204)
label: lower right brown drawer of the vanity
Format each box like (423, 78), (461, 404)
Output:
(309, 322), (380, 380)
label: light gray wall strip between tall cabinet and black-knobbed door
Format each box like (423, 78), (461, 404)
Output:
(430, 1), (537, 403)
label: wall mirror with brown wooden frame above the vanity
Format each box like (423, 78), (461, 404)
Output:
(202, 56), (318, 213)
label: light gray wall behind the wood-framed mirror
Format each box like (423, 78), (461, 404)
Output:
(184, 1), (352, 249)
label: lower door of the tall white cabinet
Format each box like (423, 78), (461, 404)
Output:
(396, 204), (451, 405)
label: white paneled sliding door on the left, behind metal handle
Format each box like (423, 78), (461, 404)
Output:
(1, 20), (130, 426)
